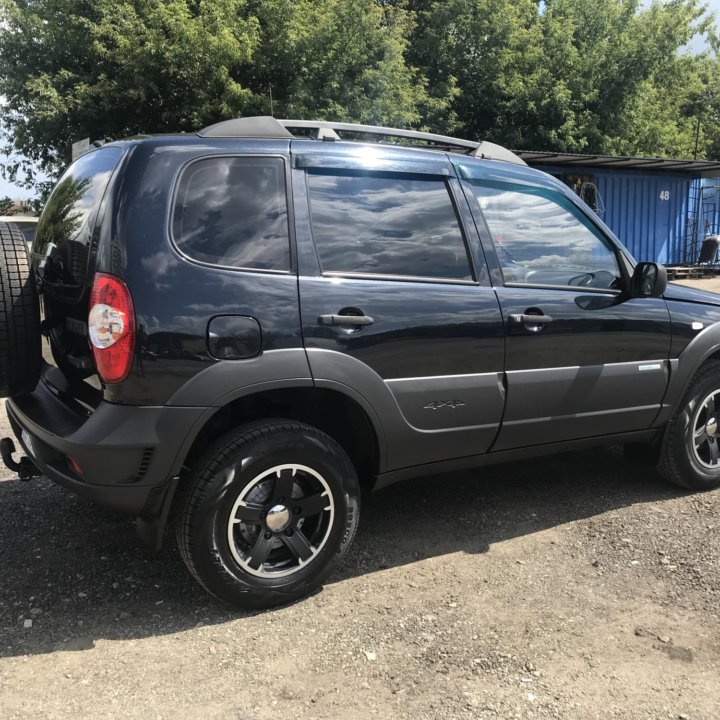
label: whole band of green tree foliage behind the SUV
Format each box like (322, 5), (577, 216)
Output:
(0, 0), (720, 193)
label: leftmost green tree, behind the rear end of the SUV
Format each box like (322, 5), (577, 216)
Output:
(0, 0), (259, 179)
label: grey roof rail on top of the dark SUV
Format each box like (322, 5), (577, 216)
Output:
(198, 115), (527, 165)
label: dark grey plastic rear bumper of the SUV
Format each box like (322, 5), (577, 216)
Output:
(6, 380), (207, 517)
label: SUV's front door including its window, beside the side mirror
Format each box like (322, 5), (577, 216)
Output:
(464, 171), (671, 450)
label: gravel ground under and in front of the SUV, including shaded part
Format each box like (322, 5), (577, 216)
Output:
(0, 382), (720, 720)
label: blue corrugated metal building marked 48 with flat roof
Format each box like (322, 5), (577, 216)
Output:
(518, 151), (720, 265)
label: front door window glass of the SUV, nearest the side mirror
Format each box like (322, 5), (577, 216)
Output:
(474, 185), (621, 289)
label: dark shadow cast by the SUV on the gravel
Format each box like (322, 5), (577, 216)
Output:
(0, 448), (681, 657)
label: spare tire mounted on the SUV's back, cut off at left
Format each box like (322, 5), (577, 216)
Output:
(0, 223), (41, 397)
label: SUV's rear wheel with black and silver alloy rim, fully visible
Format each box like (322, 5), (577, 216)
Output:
(176, 420), (360, 609)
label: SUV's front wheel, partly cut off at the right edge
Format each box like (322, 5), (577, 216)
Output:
(658, 361), (720, 490)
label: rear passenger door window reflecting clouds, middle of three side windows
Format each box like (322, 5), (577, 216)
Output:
(308, 173), (472, 280)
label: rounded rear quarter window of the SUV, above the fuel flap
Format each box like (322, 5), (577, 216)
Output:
(173, 157), (290, 270)
